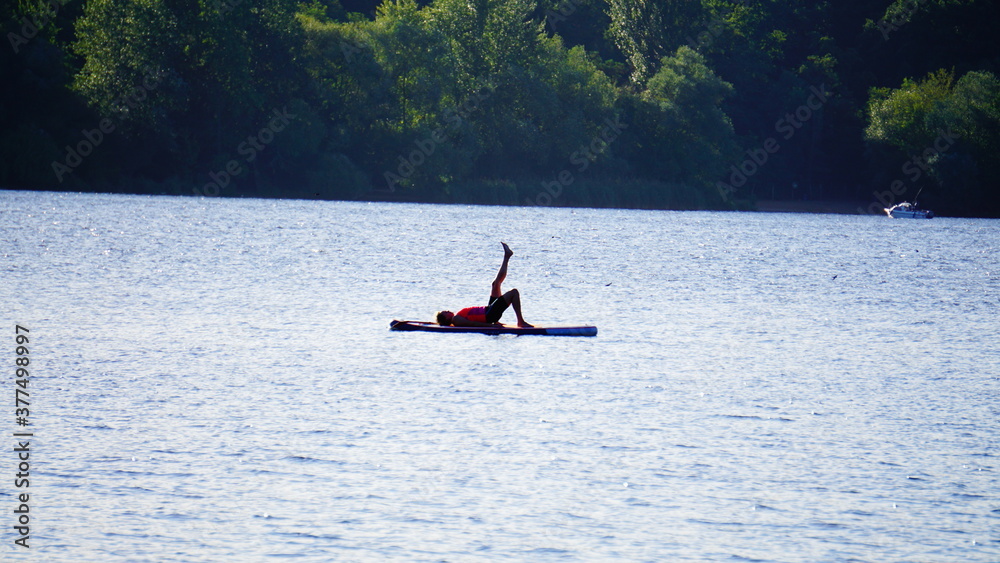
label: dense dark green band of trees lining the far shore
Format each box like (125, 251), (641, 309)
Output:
(0, 0), (1000, 216)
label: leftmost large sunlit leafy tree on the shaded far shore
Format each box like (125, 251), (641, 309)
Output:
(75, 0), (312, 189)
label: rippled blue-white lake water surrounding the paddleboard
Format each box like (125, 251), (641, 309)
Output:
(0, 191), (1000, 562)
